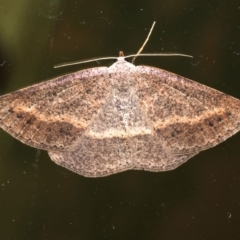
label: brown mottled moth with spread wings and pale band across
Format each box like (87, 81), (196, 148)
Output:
(0, 52), (240, 177)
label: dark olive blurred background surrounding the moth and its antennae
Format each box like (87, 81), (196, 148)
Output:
(0, 0), (240, 240)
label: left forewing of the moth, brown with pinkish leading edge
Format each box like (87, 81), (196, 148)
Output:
(0, 67), (109, 151)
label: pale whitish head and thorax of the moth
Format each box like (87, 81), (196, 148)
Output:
(108, 57), (136, 92)
